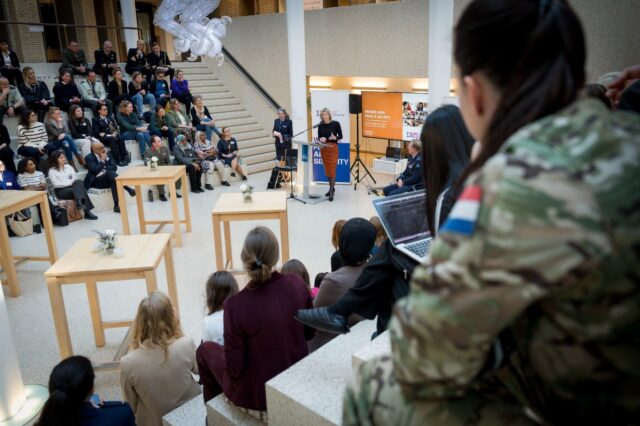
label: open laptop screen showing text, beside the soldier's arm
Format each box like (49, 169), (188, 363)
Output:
(373, 190), (429, 245)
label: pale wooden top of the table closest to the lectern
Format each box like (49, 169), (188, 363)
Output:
(212, 191), (287, 214)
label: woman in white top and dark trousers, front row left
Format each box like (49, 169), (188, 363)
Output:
(49, 151), (98, 220)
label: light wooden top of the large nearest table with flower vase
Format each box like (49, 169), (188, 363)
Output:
(44, 234), (171, 277)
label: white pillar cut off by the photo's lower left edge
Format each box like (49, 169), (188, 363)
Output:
(0, 288), (27, 423)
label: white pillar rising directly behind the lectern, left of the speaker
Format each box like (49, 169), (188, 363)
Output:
(286, 0), (312, 198)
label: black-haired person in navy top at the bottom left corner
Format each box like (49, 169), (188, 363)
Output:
(36, 355), (136, 426)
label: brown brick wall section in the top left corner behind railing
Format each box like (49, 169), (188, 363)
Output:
(5, 0), (47, 62)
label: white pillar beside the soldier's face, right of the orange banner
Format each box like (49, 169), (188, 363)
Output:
(428, 0), (453, 111)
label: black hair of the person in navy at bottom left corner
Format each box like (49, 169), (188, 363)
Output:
(36, 356), (95, 426)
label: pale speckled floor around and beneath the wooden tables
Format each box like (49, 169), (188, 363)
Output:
(0, 172), (391, 400)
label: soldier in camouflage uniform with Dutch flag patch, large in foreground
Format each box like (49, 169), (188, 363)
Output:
(343, 0), (640, 425)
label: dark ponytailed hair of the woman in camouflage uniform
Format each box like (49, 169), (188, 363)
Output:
(454, 0), (585, 179)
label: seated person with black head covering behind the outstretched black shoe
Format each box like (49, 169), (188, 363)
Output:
(309, 217), (376, 352)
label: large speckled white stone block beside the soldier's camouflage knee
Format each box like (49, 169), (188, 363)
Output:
(266, 321), (376, 426)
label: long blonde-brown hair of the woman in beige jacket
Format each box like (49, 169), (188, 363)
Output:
(130, 291), (184, 356)
